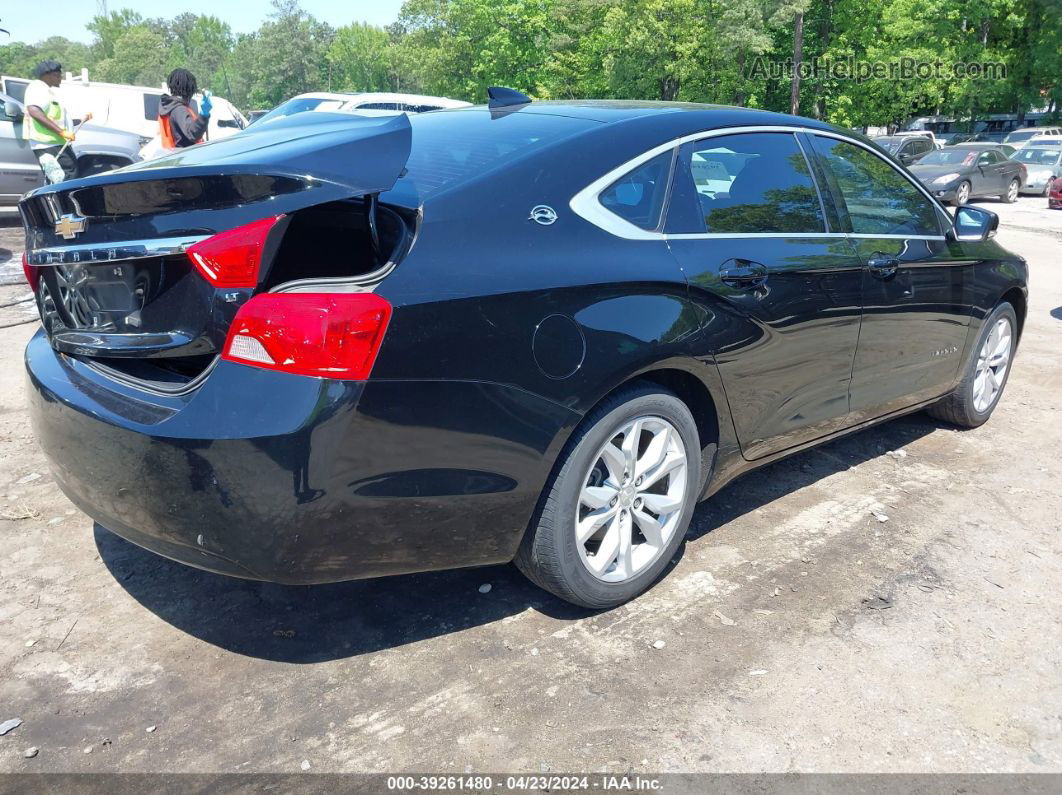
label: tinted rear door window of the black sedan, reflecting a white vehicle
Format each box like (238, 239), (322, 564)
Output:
(668, 133), (825, 235)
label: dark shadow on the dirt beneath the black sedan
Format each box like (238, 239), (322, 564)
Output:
(96, 414), (938, 663)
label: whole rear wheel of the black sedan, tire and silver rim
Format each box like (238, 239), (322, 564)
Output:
(515, 383), (701, 609)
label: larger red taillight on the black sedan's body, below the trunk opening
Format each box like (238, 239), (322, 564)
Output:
(222, 293), (391, 381)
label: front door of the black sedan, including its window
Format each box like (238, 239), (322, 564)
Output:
(810, 134), (974, 421)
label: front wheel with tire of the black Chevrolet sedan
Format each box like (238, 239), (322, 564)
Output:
(926, 301), (1017, 428)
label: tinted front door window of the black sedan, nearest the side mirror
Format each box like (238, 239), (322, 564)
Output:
(813, 136), (940, 235)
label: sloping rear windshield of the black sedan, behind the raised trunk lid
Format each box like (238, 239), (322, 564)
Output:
(400, 110), (600, 198)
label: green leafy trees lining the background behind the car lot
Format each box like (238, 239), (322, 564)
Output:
(0, 0), (1062, 126)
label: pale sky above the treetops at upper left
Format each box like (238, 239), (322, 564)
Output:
(0, 0), (401, 44)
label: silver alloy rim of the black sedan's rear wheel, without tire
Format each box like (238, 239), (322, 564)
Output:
(573, 416), (688, 583)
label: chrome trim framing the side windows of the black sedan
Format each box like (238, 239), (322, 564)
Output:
(568, 124), (950, 241)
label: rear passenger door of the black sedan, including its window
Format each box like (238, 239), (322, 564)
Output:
(665, 131), (862, 459)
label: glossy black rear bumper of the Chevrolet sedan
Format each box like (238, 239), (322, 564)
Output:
(25, 332), (578, 584)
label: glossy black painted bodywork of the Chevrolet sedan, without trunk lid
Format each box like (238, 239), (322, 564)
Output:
(18, 103), (1026, 583)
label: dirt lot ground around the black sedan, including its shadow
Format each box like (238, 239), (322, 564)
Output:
(0, 198), (1062, 773)
